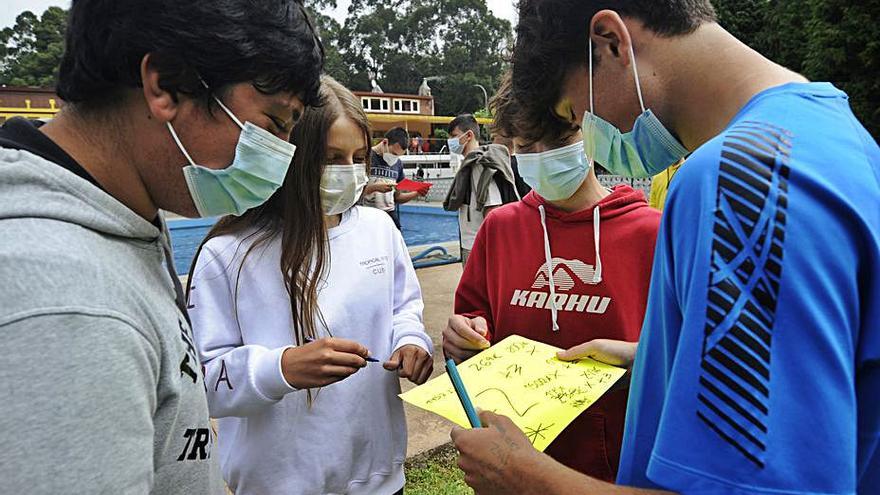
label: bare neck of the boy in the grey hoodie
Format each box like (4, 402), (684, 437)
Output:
(40, 110), (158, 221)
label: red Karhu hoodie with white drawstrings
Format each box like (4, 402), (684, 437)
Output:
(455, 185), (660, 482)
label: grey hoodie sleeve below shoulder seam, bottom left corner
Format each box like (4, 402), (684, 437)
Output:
(0, 310), (158, 493)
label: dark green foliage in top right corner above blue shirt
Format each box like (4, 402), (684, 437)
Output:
(712, 0), (880, 139)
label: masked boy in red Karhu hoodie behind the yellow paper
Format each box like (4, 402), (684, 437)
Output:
(443, 75), (660, 481)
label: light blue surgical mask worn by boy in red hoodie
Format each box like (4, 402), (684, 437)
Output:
(516, 140), (593, 201)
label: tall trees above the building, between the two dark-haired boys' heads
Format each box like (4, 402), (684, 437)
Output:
(334, 0), (512, 115)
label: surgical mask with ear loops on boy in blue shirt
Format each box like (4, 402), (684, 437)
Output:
(581, 38), (688, 177)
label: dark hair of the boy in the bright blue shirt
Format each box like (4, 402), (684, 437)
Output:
(511, 0), (716, 142)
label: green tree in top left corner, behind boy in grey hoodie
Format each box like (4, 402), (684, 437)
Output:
(0, 7), (67, 87)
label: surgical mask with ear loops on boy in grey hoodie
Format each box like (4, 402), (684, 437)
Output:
(166, 83), (296, 217)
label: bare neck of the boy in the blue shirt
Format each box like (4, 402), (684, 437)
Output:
(657, 23), (808, 151)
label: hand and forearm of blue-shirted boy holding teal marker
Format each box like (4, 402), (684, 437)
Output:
(452, 411), (670, 495)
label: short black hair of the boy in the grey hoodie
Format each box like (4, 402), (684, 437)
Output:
(56, 0), (324, 109)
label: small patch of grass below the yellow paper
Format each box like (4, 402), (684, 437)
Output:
(404, 443), (474, 495)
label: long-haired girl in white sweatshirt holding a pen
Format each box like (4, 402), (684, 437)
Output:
(187, 76), (433, 495)
